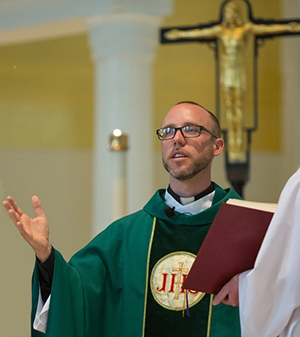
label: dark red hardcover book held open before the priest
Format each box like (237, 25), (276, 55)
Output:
(183, 199), (276, 294)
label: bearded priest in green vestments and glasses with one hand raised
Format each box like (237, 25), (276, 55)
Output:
(3, 101), (240, 337)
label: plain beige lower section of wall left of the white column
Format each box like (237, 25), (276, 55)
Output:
(0, 150), (92, 337)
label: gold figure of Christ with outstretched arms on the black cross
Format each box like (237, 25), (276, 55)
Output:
(164, 1), (300, 162)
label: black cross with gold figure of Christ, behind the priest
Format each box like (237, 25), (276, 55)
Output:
(161, 0), (300, 196)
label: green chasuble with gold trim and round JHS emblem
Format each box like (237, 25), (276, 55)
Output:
(32, 184), (241, 337)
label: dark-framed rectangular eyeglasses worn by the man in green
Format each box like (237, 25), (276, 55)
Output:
(156, 125), (219, 140)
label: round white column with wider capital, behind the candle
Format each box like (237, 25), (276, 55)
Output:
(89, 9), (171, 234)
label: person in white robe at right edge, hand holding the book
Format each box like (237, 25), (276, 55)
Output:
(214, 168), (300, 337)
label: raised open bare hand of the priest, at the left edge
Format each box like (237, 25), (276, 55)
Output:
(3, 196), (51, 262)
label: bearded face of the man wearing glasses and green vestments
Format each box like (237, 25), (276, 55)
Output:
(162, 103), (215, 181)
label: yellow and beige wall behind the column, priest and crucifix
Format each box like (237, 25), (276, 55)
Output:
(0, 0), (293, 337)
